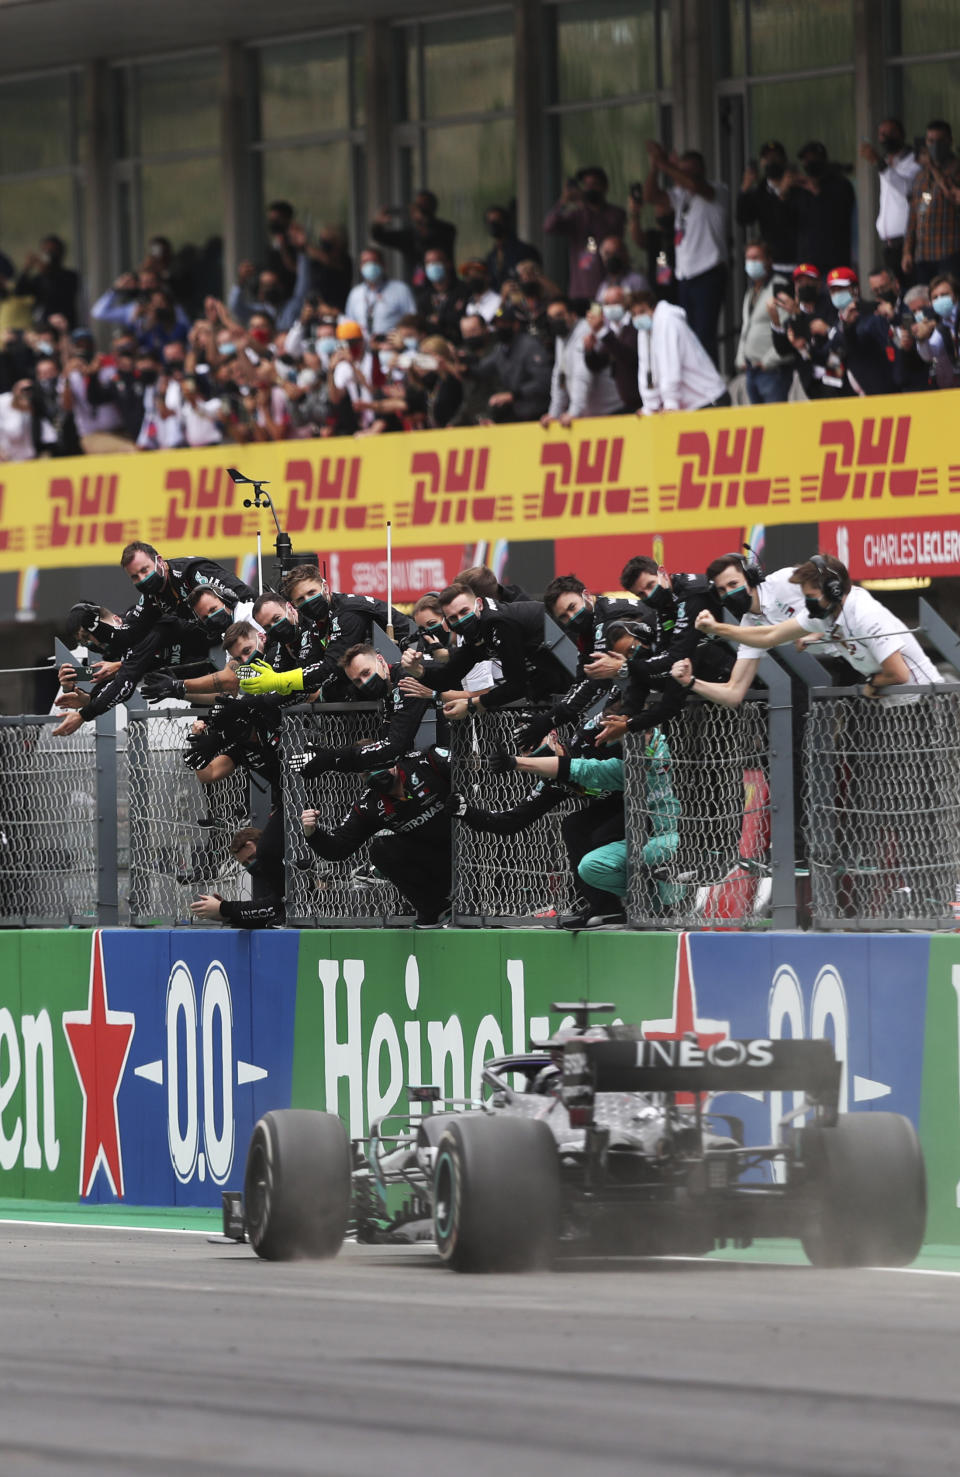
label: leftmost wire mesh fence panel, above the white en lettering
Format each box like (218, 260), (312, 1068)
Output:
(0, 715), (97, 926)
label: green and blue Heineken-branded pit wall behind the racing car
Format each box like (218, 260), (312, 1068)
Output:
(0, 929), (960, 1244)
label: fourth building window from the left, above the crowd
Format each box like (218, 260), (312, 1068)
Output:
(394, 10), (515, 264)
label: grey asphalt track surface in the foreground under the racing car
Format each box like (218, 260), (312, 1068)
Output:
(0, 1224), (960, 1477)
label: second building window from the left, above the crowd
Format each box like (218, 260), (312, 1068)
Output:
(114, 50), (223, 312)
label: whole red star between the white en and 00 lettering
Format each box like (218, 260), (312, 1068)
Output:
(64, 929), (136, 1199)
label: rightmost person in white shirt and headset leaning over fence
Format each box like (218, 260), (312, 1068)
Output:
(697, 554), (942, 697)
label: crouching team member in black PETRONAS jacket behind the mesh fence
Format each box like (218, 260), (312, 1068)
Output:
(303, 749), (450, 926)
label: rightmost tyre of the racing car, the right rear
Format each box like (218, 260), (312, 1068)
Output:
(800, 1112), (926, 1267)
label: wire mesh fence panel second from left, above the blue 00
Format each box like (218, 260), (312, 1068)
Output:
(118, 709), (250, 925)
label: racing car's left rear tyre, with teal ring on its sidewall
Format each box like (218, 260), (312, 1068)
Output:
(433, 1112), (560, 1272)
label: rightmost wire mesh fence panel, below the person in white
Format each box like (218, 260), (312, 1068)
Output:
(803, 691), (960, 929)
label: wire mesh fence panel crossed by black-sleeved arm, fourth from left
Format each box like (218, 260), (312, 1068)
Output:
(450, 709), (583, 925)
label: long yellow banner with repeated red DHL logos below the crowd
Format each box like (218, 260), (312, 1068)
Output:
(0, 390), (960, 570)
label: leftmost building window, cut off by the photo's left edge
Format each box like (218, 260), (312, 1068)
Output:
(0, 72), (84, 286)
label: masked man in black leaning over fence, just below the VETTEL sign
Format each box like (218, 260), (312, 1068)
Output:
(403, 582), (569, 718)
